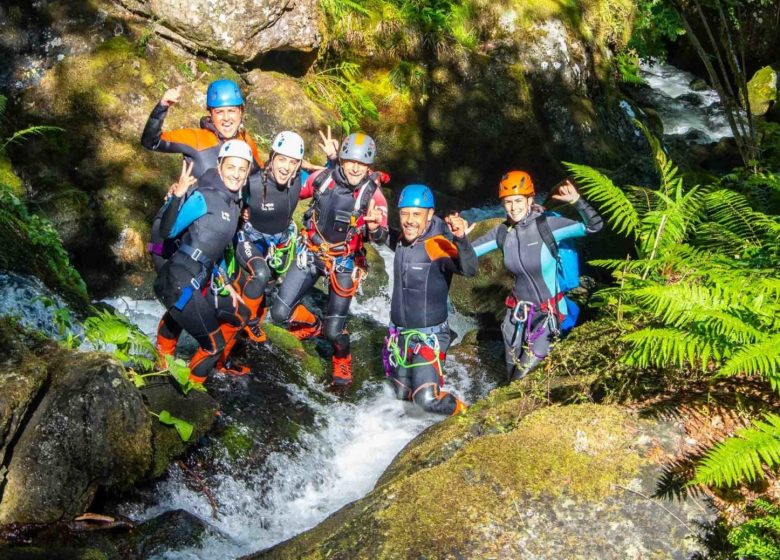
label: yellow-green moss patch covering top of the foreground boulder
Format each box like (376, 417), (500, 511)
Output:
(376, 405), (641, 558)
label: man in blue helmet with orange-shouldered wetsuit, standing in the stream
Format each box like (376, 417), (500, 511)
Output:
(382, 184), (477, 415)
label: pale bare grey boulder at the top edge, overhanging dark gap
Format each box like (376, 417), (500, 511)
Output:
(109, 0), (321, 63)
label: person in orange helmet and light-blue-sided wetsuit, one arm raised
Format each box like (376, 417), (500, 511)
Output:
(473, 171), (603, 381)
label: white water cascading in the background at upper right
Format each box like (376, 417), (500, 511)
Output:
(641, 63), (732, 143)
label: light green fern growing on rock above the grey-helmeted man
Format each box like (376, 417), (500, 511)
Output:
(303, 62), (379, 134)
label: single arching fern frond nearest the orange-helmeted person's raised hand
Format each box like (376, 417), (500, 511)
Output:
(563, 162), (639, 238)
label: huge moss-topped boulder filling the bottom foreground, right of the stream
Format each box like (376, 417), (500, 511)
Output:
(254, 400), (709, 559)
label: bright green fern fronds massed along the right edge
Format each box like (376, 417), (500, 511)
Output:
(567, 130), (780, 494)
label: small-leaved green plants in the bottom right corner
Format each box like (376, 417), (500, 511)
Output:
(728, 500), (780, 560)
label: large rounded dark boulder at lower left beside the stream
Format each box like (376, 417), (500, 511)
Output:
(0, 353), (152, 523)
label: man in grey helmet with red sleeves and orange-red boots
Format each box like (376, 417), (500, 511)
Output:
(271, 128), (389, 386)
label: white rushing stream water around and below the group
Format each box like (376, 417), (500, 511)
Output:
(105, 238), (494, 560)
